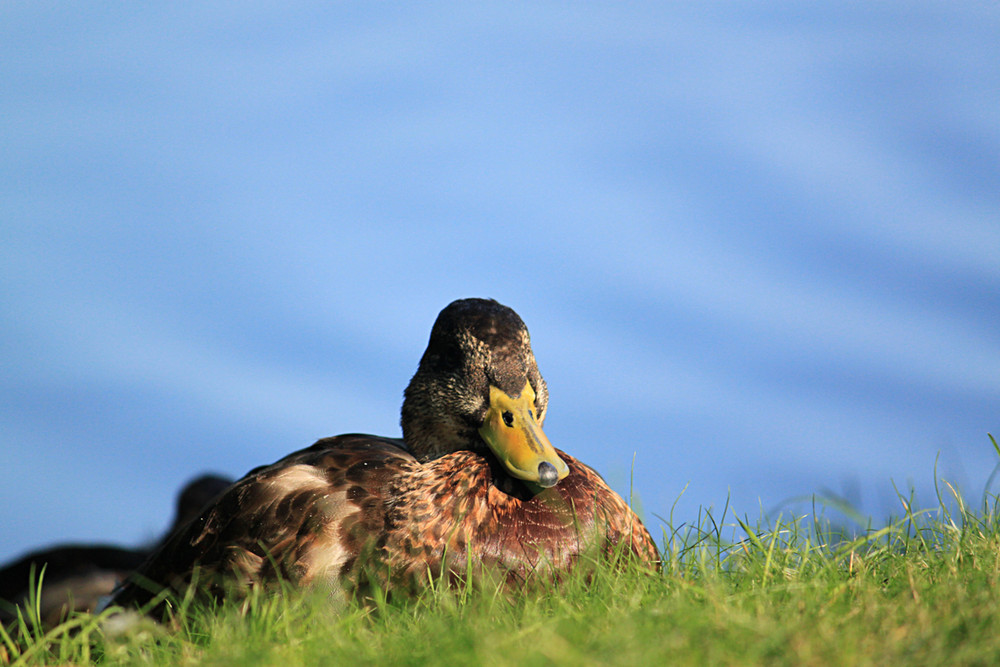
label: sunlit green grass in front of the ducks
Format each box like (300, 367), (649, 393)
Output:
(0, 436), (1000, 667)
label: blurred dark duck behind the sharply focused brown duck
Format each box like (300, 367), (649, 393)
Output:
(0, 475), (232, 627)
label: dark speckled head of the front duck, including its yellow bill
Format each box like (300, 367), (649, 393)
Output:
(401, 299), (569, 487)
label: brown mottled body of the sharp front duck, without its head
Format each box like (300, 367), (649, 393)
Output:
(114, 434), (658, 606)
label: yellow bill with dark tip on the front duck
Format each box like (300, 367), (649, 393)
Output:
(479, 382), (569, 488)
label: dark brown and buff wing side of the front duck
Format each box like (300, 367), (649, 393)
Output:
(113, 435), (416, 606)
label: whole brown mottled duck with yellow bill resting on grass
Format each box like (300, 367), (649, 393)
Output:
(112, 299), (659, 612)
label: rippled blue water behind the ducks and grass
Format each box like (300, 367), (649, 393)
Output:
(0, 1), (1000, 560)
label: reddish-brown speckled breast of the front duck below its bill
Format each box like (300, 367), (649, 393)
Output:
(385, 451), (659, 581)
